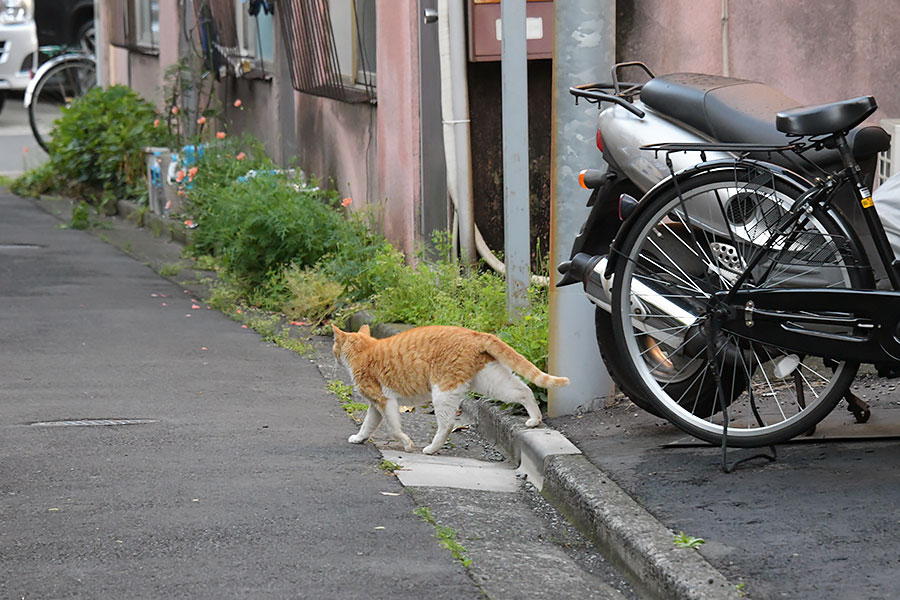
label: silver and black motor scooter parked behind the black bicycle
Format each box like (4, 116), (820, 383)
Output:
(556, 62), (890, 413)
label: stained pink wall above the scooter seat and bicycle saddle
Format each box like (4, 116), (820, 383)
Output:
(617, 0), (900, 121)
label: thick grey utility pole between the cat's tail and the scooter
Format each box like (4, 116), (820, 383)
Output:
(544, 0), (616, 417)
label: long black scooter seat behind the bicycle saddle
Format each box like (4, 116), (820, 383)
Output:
(641, 73), (890, 166)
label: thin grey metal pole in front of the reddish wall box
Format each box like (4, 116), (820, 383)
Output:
(500, 0), (531, 320)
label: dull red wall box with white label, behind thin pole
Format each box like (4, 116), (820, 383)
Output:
(468, 0), (553, 61)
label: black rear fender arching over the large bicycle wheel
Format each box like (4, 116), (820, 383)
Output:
(605, 158), (824, 277)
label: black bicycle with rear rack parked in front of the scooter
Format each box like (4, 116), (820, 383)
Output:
(602, 97), (900, 458)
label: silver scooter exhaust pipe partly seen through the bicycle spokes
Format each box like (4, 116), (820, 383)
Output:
(558, 252), (697, 327)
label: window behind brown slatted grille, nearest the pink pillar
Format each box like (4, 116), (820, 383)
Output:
(278, 0), (375, 102)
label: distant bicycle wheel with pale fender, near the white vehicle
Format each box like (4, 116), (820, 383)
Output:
(25, 46), (97, 152)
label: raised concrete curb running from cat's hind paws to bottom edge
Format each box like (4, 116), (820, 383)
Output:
(463, 398), (741, 600)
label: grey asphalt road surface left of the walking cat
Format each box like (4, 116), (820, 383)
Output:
(0, 194), (483, 599)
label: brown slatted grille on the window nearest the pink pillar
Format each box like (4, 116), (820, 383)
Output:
(276, 0), (375, 102)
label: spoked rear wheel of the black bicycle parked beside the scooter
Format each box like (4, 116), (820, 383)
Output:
(612, 163), (867, 447)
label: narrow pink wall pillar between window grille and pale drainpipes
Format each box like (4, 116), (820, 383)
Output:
(376, 2), (421, 256)
